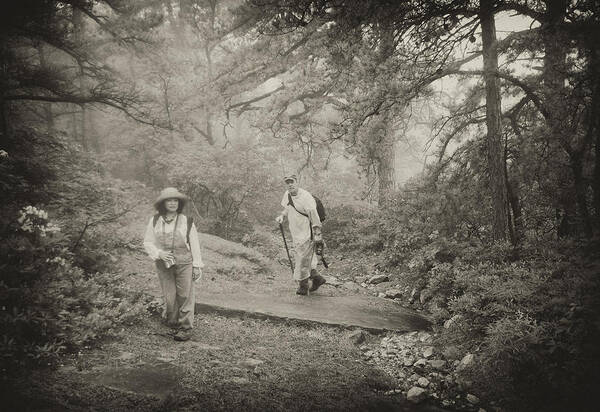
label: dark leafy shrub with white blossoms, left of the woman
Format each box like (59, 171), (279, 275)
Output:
(0, 204), (143, 371)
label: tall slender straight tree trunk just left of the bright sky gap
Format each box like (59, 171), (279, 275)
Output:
(479, 0), (508, 240)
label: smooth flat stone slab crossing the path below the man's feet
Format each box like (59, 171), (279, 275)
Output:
(196, 290), (431, 332)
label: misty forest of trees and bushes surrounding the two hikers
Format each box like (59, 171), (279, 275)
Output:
(0, 0), (600, 411)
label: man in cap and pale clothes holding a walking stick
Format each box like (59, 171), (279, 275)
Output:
(275, 175), (325, 295)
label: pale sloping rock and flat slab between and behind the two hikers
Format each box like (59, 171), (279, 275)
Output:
(131, 233), (430, 333)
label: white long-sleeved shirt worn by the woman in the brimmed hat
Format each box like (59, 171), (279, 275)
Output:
(144, 214), (204, 268)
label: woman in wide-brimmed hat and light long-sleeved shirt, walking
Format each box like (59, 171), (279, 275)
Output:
(144, 187), (204, 341)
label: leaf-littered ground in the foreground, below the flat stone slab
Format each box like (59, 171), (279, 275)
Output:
(4, 315), (436, 411)
